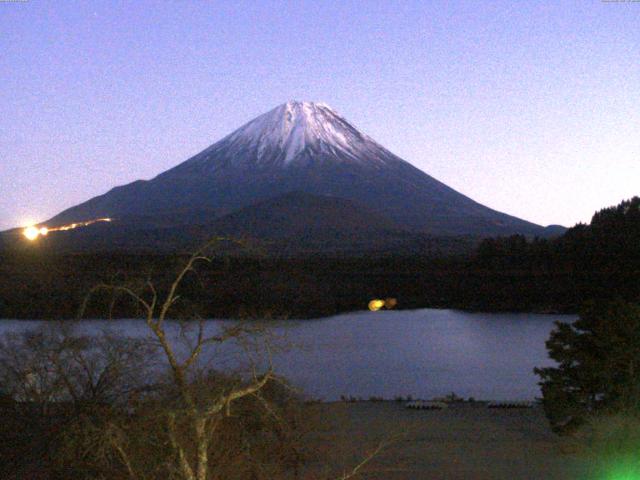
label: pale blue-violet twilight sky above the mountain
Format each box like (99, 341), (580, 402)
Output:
(0, 0), (640, 229)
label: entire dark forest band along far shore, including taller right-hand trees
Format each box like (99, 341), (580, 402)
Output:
(0, 197), (640, 318)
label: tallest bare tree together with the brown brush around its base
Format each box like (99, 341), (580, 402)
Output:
(69, 239), (385, 480)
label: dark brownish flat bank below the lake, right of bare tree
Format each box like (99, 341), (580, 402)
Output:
(302, 402), (594, 480)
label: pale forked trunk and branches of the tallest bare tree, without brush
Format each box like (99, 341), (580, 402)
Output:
(80, 239), (276, 480)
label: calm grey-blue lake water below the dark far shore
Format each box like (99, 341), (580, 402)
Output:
(0, 309), (575, 400)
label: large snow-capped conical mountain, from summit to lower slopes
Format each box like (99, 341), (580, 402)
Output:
(43, 101), (548, 248)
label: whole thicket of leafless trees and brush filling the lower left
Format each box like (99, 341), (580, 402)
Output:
(0, 239), (396, 480)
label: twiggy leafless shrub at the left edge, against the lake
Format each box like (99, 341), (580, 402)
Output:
(0, 322), (152, 413)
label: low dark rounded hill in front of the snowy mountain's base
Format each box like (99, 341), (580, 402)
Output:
(203, 192), (450, 255)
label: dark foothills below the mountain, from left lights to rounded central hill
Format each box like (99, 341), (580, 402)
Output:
(0, 192), (475, 257)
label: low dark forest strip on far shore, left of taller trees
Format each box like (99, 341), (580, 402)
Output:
(0, 254), (464, 319)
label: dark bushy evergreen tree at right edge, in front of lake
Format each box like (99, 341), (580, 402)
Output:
(535, 300), (640, 432)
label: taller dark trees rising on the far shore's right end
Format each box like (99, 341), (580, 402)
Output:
(469, 197), (640, 312)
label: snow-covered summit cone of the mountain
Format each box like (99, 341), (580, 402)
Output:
(178, 101), (386, 171)
